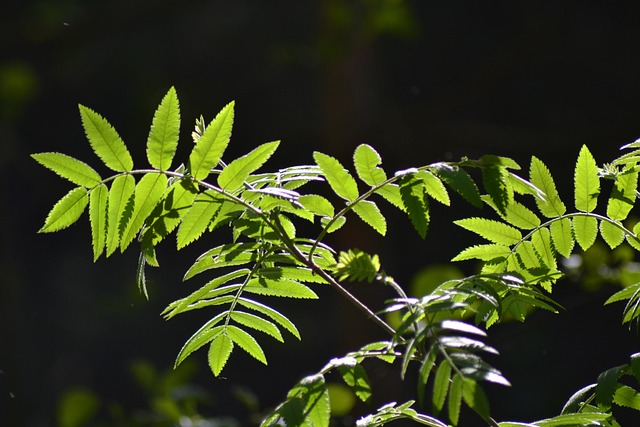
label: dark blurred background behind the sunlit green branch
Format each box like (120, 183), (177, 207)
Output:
(0, 0), (640, 426)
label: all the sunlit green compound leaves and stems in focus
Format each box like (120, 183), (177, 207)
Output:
(33, 88), (640, 427)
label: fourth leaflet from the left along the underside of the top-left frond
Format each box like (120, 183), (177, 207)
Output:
(120, 173), (167, 252)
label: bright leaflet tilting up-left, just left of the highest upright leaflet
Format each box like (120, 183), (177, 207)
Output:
(79, 105), (133, 172)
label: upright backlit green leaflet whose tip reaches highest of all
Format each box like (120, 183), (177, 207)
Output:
(147, 87), (180, 171)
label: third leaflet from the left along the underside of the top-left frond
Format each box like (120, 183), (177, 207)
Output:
(107, 175), (136, 256)
